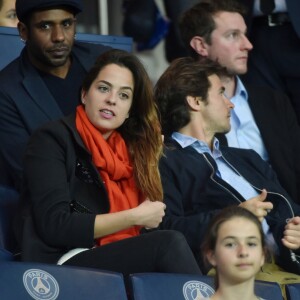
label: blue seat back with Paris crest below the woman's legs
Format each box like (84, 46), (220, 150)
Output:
(0, 262), (127, 300)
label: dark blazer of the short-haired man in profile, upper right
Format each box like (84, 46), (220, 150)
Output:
(217, 84), (300, 204)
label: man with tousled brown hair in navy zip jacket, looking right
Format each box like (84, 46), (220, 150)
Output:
(155, 57), (300, 274)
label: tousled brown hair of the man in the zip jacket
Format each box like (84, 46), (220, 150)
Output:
(154, 57), (227, 135)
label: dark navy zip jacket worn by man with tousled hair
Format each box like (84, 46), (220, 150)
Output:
(159, 138), (300, 274)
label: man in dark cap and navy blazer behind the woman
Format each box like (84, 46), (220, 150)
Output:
(0, 0), (109, 190)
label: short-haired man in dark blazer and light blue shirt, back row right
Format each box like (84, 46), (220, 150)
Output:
(180, 0), (300, 204)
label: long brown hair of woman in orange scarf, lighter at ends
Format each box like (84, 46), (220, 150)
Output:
(82, 49), (163, 201)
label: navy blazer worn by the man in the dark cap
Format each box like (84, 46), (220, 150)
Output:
(0, 43), (110, 190)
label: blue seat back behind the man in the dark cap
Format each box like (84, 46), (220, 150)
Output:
(0, 26), (133, 70)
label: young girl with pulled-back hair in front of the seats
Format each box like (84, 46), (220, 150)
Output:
(203, 206), (266, 300)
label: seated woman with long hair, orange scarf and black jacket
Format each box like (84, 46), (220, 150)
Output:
(15, 50), (201, 282)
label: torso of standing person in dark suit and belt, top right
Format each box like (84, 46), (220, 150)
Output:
(241, 0), (300, 122)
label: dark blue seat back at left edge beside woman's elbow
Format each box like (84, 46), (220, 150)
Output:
(0, 185), (19, 251)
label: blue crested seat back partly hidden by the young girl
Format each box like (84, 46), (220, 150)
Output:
(130, 273), (284, 300)
